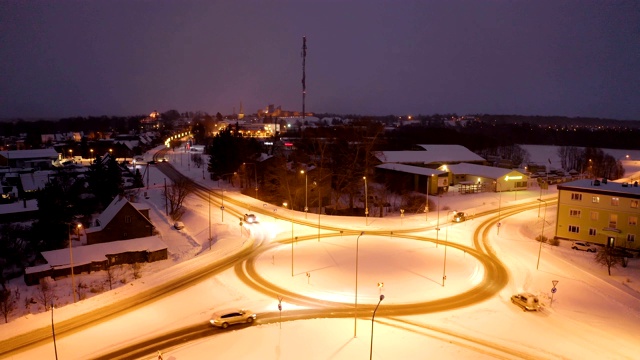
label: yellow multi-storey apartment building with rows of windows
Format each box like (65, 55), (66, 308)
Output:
(556, 179), (640, 250)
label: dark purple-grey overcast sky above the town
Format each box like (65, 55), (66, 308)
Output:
(0, 0), (640, 120)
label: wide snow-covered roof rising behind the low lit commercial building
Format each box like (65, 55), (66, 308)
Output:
(376, 145), (485, 164)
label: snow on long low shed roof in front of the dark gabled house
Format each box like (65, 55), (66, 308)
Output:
(25, 236), (167, 274)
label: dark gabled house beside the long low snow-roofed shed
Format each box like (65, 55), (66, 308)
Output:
(85, 196), (154, 245)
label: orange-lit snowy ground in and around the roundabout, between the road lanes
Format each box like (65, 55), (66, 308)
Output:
(0, 147), (640, 359)
